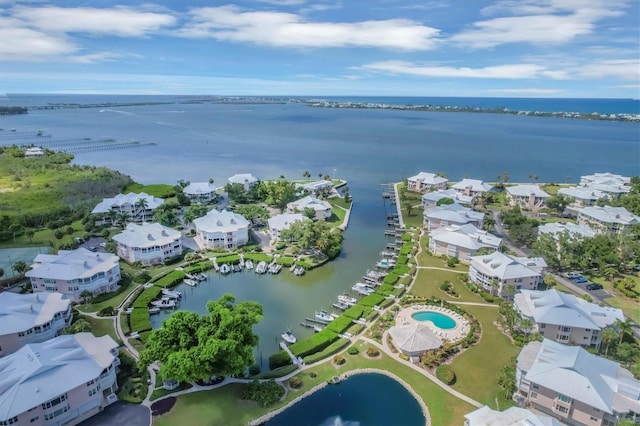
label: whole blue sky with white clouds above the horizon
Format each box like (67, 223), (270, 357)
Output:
(0, 0), (640, 98)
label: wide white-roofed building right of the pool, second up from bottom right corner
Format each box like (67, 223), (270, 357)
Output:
(513, 289), (624, 348)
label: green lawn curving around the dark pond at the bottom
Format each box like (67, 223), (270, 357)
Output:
(153, 341), (474, 426)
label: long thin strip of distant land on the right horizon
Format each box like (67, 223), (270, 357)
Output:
(304, 99), (640, 122)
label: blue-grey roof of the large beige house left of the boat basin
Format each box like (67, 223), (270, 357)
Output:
(26, 247), (118, 281)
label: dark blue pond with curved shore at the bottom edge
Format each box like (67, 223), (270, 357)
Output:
(266, 374), (429, 426)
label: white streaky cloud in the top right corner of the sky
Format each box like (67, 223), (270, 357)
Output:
(451, 0), (627, 48)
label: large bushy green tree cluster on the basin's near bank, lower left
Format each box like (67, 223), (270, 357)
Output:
(138, 294), (262, 382)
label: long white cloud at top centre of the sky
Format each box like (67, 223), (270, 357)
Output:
(179, 6), (439, 50)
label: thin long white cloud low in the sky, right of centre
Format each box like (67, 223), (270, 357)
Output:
(355, 61), (561, 79)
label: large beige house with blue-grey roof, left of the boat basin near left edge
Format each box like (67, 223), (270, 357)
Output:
(26, 247), (120, 301)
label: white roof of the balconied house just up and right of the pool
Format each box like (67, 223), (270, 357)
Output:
(469, 251), (546, 280)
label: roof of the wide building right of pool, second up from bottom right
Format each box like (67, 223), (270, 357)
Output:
(514, 289), (624, 330)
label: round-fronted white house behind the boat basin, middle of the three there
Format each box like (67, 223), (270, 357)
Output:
(193, 210), (249, 249)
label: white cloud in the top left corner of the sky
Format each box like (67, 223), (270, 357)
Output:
(12, 6), (176, 37)
